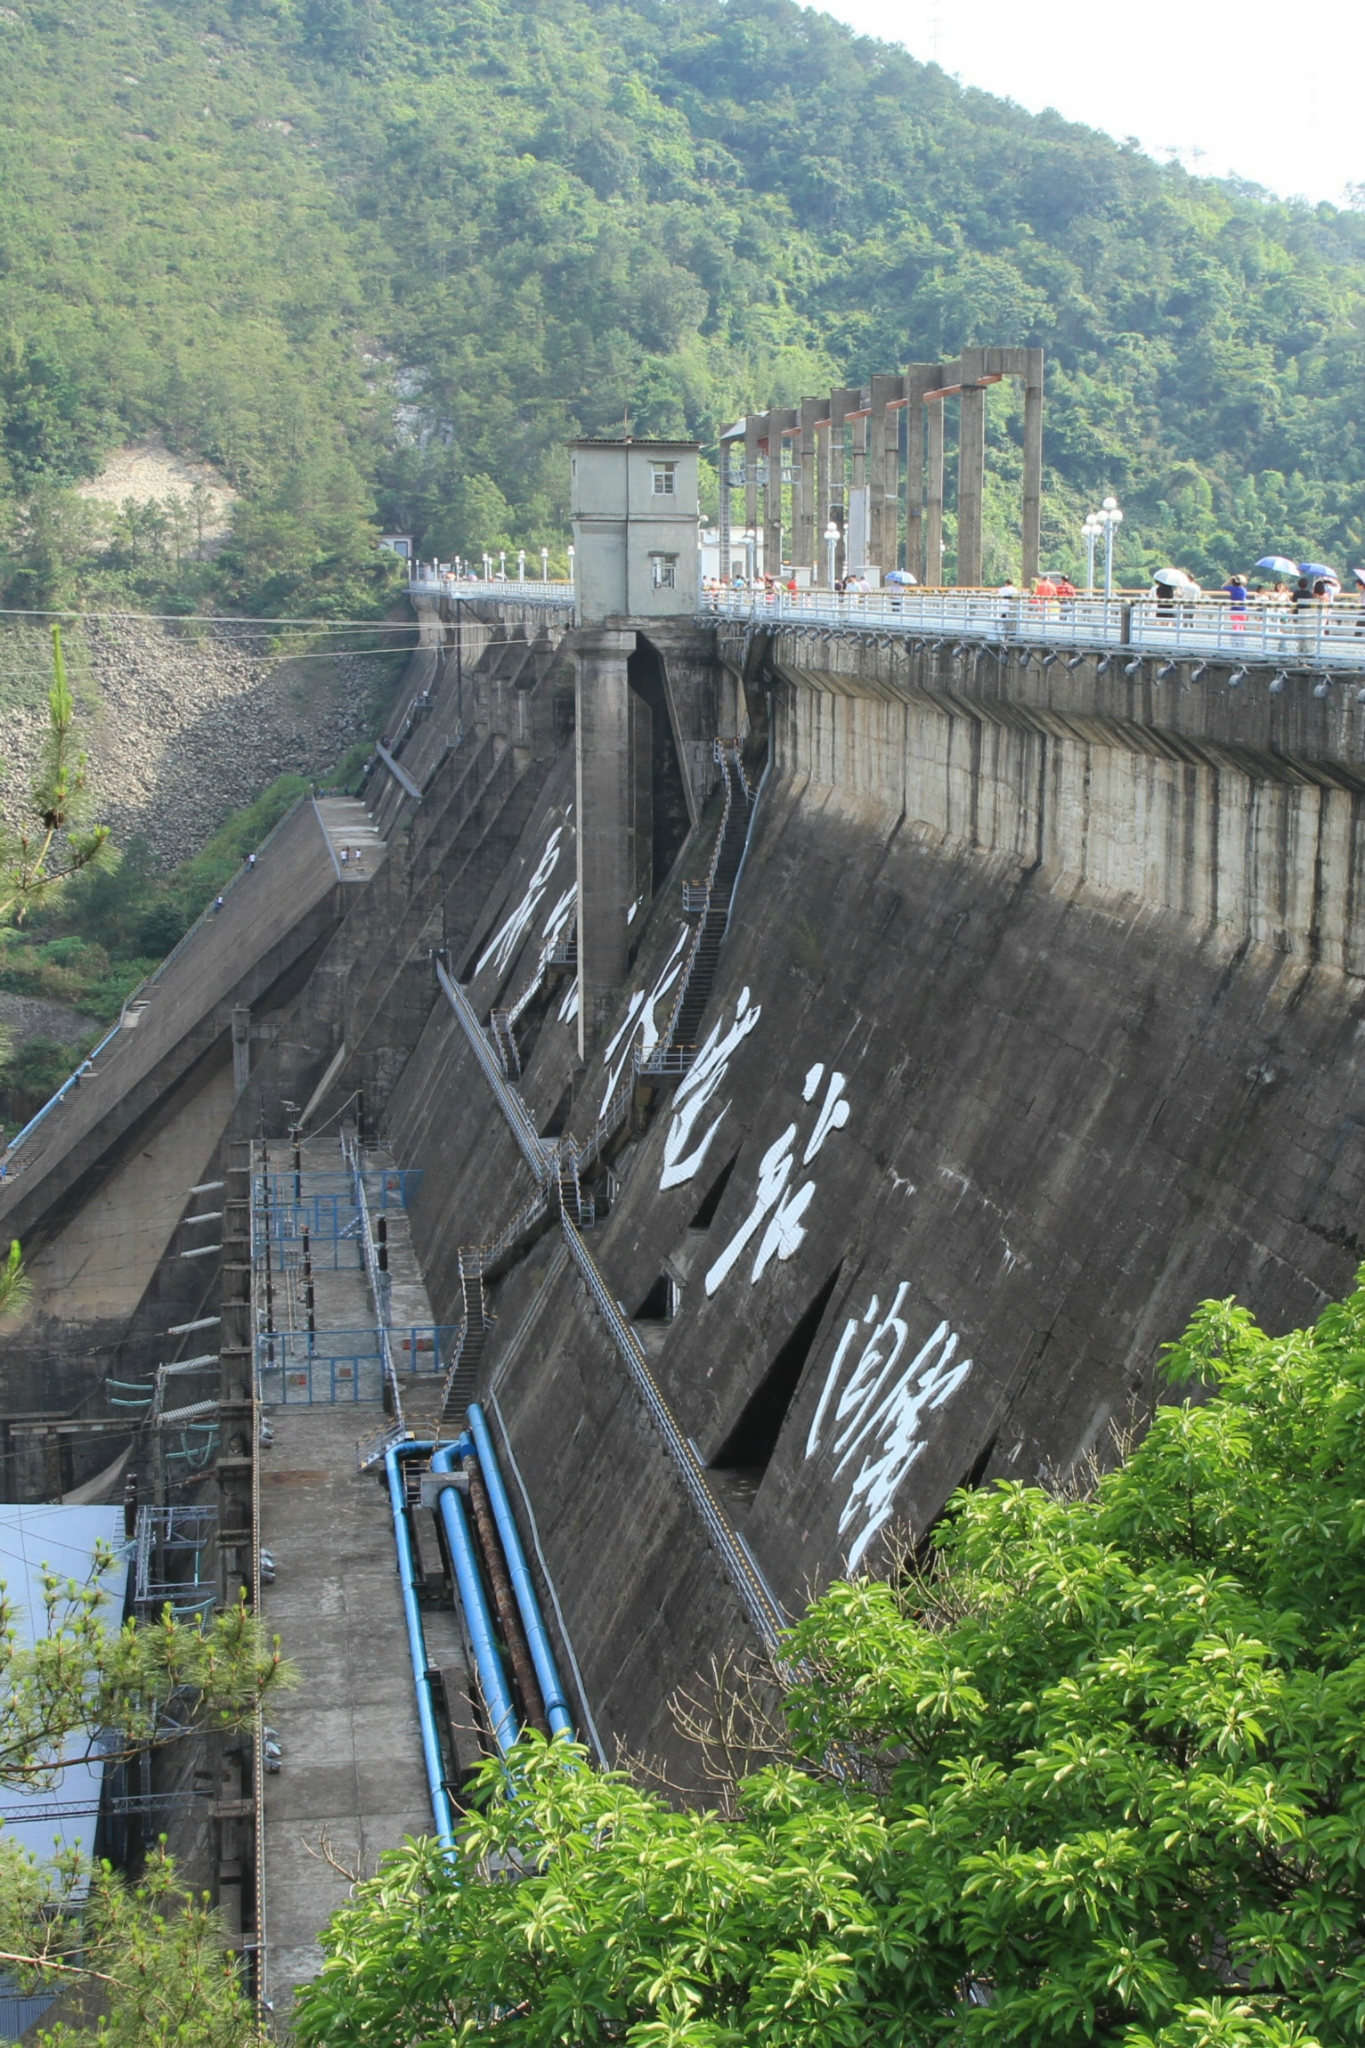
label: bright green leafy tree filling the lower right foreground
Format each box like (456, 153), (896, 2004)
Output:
(297, 1272), (1365, 2048)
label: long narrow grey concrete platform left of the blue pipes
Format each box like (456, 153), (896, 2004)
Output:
(256, 1138), (450, 2030)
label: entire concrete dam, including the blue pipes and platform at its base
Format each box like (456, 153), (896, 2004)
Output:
(0, 428), (1365, 2011)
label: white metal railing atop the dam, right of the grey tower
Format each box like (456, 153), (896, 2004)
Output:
(702, 588), (1365, 680)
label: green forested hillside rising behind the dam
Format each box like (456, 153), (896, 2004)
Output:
(0, 0), (1365, 610)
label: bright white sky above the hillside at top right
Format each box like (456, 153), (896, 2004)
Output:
(823, 0), (1365, 205)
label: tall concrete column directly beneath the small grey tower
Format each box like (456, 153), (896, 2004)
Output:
(573, 627), (634, 1059)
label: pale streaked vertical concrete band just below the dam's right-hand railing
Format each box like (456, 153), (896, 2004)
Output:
(776, 635), (1365, 975)
